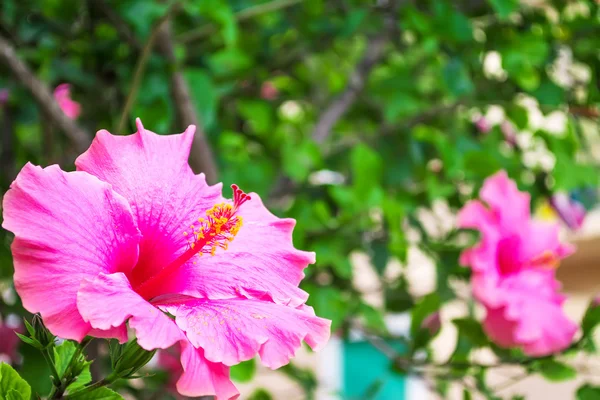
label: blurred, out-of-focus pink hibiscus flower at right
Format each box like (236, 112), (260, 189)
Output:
(458, 171), (577, 356)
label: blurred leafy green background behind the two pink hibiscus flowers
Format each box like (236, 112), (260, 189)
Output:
(0, 0), (600, 400)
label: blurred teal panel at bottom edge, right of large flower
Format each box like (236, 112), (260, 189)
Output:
(342, 341), (406, 400)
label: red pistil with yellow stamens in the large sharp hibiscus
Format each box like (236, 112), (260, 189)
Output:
(133, 185), (250, 299)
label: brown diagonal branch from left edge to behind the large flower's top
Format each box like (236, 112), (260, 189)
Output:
(0, 35), (90, 152)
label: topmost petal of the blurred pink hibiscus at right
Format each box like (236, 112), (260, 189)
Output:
(479, 171), (530, 232)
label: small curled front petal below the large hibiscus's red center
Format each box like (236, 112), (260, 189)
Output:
(77, 273), (185, 350)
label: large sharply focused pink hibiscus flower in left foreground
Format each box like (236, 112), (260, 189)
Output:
(3, 119), (330, 399)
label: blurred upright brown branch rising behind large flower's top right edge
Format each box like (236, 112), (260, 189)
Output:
(156, 21), (217, 183)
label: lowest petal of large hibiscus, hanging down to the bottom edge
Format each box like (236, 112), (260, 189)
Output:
(177, 340), (239, 400)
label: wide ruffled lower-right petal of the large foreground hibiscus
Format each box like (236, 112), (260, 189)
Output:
(157, 299), (331, 369)
